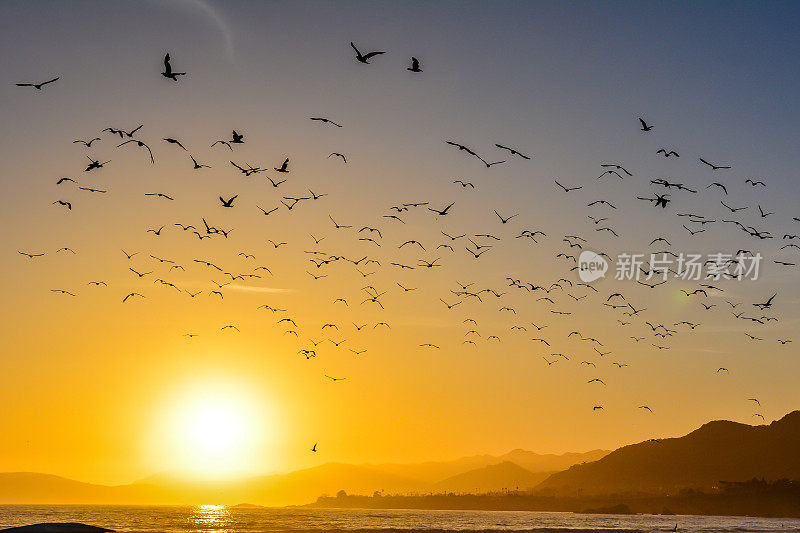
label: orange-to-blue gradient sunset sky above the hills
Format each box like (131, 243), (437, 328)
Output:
(0, 0), (800, 483)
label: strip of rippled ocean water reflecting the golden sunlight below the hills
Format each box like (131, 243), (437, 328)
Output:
(0, 505), (800, 533)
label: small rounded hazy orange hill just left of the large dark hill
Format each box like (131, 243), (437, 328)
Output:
(431, 461), (550, 493)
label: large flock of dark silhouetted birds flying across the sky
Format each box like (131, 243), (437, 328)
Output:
(12, 42), (800, 444)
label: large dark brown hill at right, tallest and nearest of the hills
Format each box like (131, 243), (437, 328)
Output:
(537, 411), (800, 494)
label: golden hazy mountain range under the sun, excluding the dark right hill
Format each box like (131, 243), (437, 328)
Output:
(0, 450), (608, 505)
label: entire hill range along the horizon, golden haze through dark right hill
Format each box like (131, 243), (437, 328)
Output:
(6, 411), (800, 505)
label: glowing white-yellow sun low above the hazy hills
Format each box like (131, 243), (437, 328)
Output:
(155, 382), (276, 478)
